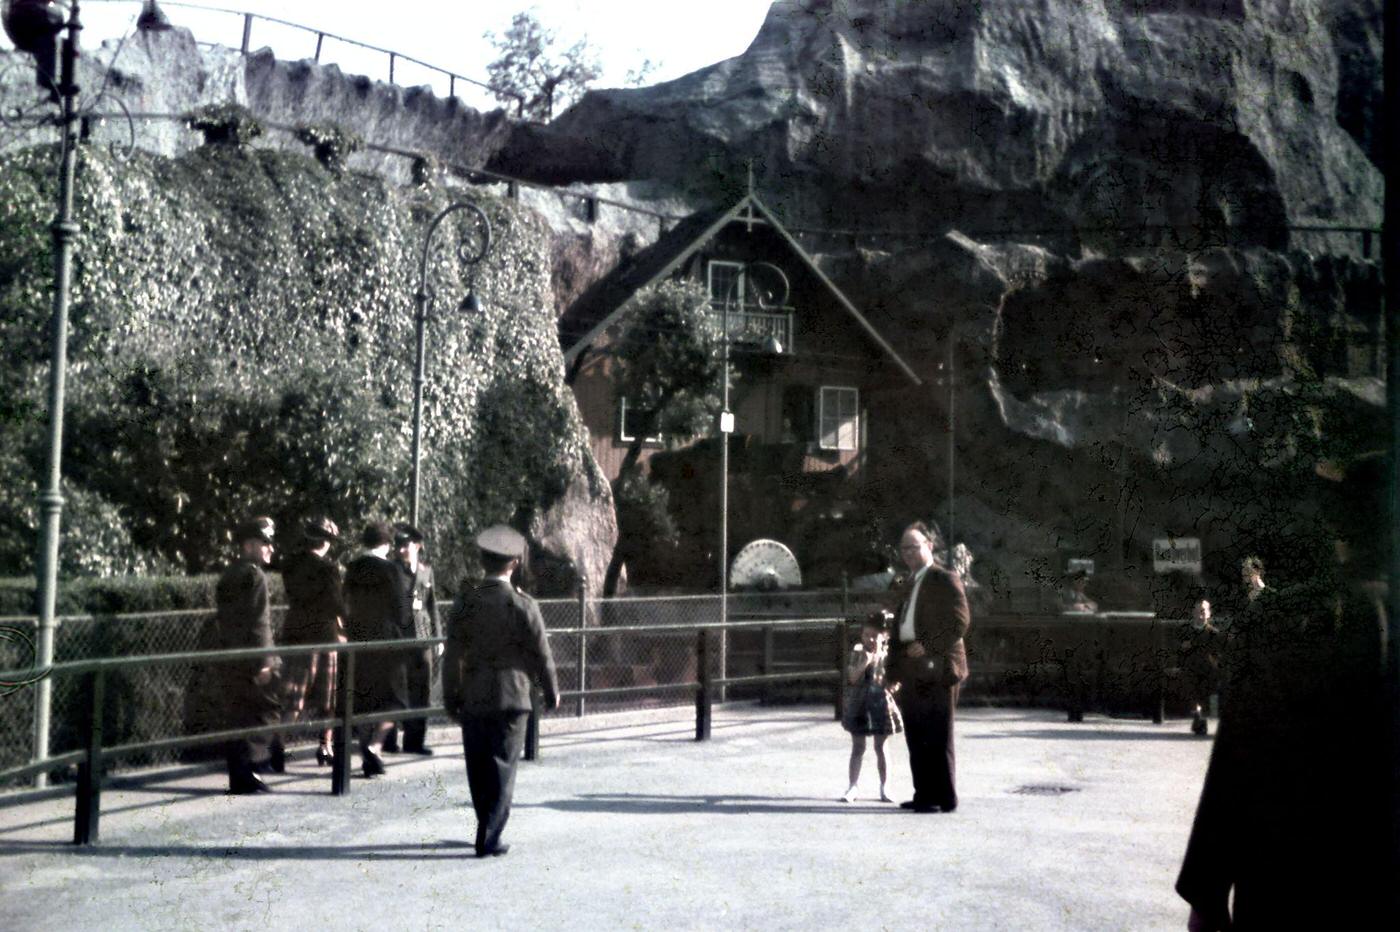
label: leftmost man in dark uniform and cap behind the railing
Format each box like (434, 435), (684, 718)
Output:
(213, 518), (281, 795)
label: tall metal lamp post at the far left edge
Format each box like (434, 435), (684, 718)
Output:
(4, 0), (83, 786)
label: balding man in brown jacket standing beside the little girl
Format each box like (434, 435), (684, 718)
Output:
(888, 522), (972, 812)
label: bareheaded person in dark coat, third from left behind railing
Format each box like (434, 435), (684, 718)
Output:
(344, 522), (413, 777)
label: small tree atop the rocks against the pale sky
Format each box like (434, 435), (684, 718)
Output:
(486, 13), (602, 120)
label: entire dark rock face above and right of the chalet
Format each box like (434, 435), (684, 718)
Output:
(490, 0), (1383, 596)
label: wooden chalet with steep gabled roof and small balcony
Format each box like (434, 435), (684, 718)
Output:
(560, 192), (920, 484)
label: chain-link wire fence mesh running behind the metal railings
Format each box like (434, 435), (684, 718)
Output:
(0, 591), (1204, 770)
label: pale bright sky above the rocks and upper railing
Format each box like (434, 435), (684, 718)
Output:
(63, 0), (770, 108)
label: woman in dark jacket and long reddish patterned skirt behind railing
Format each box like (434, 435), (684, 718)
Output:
(281, 518), (346, 765)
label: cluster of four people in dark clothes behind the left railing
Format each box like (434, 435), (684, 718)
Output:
(210, 518), (438, 795)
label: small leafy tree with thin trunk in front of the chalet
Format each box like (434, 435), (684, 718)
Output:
(603, 281), (724, 595)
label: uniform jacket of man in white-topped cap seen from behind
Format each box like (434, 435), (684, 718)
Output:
(442, 579), (559, 715)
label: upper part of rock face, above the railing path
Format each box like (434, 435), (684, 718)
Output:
(496, 0), (1382, 238)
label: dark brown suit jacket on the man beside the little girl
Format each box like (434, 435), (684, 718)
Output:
(888, 565), (972, 686)
